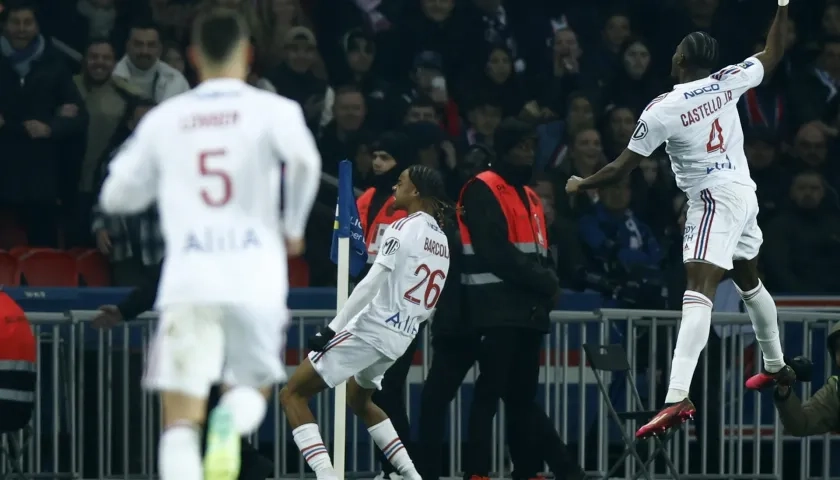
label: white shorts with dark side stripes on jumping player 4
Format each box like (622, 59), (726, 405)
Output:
(683, 184), (763, 270)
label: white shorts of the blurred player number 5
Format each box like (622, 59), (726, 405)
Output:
(143, 304), (289, 398)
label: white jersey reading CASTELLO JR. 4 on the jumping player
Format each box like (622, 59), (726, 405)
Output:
(627, 57), (764, 197)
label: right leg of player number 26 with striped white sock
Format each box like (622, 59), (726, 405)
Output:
(347, 362), (420, 480)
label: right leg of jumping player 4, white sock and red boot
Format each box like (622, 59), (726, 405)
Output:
(732, 218), (796, 390)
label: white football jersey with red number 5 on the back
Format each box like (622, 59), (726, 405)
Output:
(100, 79), (321, 307)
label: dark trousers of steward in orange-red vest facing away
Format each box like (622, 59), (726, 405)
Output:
(464, 328), (543, 478)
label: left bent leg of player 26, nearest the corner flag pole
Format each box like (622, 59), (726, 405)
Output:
(280, 331), (370, 480)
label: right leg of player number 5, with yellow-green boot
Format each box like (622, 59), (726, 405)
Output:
(204, 305), (287, 480)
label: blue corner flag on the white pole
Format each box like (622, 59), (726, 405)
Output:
(330, 160), (367, 277)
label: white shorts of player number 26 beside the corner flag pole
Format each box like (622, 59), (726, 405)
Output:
(309, 330), (394, 390)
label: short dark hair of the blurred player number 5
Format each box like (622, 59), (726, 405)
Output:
(192, 8), (251, 63)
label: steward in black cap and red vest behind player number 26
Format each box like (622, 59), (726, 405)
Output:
(356, 132), (424, 478)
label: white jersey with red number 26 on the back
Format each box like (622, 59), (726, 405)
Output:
(346, 212), (449, 359)
